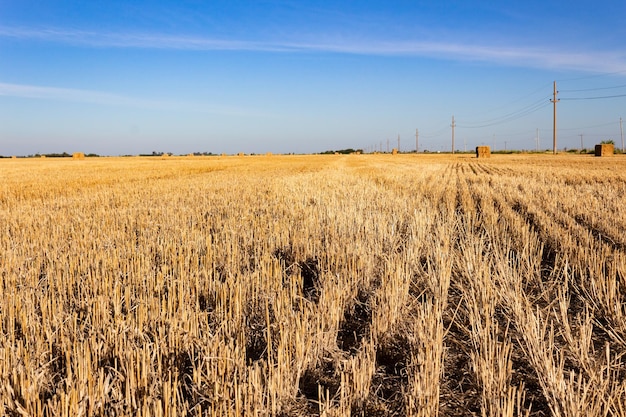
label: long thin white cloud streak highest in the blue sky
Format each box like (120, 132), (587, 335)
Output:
(0, 27), (626, 73)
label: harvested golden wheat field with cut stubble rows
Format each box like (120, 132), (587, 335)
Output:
(0, 155), (626, 416)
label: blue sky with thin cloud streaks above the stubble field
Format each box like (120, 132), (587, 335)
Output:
(0, 0), (626, 155)
